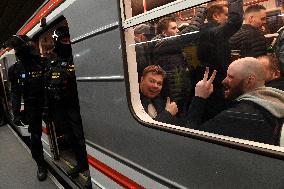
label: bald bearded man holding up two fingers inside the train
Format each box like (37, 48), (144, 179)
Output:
(187, 57), (284, 145)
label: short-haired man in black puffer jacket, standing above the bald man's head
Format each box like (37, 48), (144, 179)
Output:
(230, 4), (267, 57)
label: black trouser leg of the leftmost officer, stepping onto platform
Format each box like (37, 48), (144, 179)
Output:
(25, 104), (44, 166)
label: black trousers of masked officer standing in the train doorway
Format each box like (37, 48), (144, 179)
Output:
(50, 103), (88, 169)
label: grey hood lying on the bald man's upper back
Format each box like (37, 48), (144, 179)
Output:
(236, 87), (284, 118)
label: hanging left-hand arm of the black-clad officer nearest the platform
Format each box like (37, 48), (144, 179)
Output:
(8, 61), (25, 125)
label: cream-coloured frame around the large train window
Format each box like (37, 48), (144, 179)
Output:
(120, 0), (284, 159)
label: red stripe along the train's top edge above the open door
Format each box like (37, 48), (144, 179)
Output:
(18, 0), (64, 35)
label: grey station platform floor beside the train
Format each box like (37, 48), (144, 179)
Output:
(0, 125), (63, 189)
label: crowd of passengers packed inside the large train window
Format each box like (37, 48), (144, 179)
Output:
(134, 0), (284, 145)
